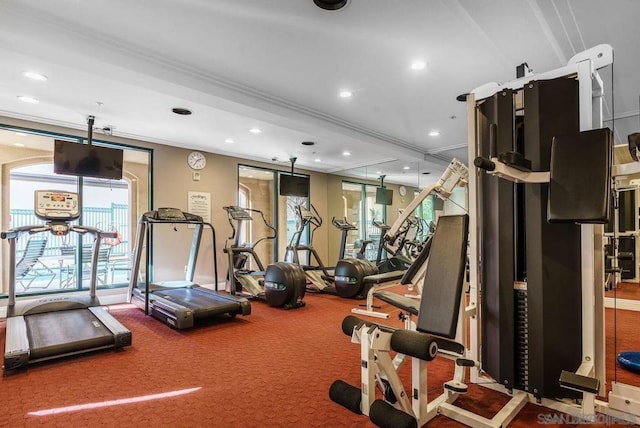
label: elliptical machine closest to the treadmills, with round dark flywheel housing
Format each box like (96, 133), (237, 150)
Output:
(223, 205), (306, 309)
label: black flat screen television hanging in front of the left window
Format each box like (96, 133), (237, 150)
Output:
(53, 140), (123, 180)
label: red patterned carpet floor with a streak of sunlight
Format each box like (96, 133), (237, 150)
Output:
(0, 294), (640, 428)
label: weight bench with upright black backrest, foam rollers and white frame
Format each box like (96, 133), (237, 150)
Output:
(329, 215), (488, 427)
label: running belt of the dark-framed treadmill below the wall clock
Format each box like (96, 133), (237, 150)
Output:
(153, 288), (241, 318)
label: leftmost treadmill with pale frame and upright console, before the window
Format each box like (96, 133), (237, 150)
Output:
(0, 190), (131, 370)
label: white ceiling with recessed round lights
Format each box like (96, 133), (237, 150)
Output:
(0, 0), (640, 186)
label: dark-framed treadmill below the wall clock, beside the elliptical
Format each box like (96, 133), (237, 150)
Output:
(128, 208), (251, 329)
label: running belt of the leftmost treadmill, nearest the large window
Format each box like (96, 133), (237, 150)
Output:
(25, 309), (114, 360)
